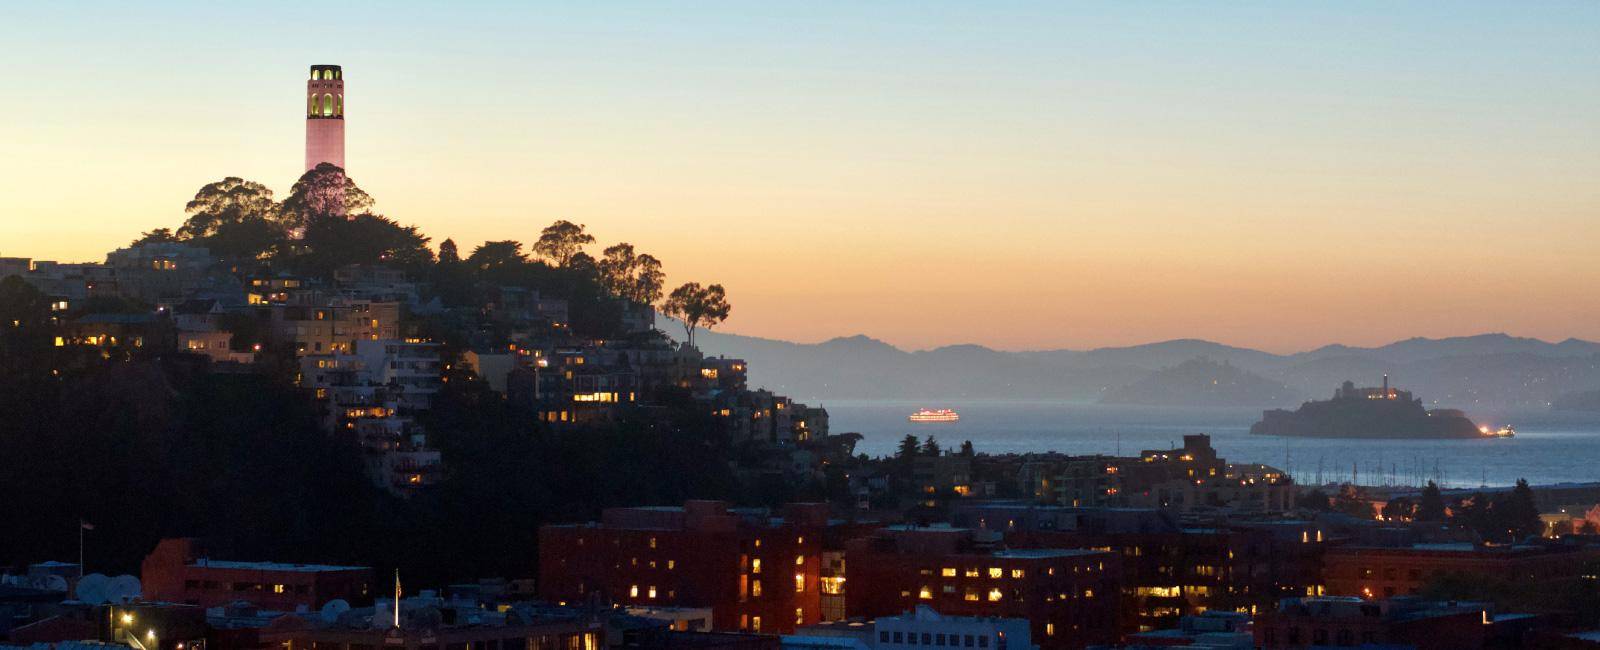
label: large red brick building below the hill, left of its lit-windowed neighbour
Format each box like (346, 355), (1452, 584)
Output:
(539, 501), (827, 632)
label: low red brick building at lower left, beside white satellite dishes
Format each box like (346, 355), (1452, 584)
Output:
(141, 538), (373, 612)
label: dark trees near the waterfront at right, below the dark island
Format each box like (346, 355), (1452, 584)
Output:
(1298, 479), (1544, 541)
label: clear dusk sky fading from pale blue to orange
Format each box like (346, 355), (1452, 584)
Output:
(0, 2), (1600, 352)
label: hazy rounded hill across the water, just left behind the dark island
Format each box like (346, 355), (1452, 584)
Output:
(1101, 357), (1304, 407)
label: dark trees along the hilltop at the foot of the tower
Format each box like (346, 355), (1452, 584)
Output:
(134, 163), (731, 344)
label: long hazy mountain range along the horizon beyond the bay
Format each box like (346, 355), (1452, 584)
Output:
(691, 327), (1600, 410)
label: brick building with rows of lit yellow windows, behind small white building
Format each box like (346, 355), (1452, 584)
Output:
(845, 527), (1120, 648)
